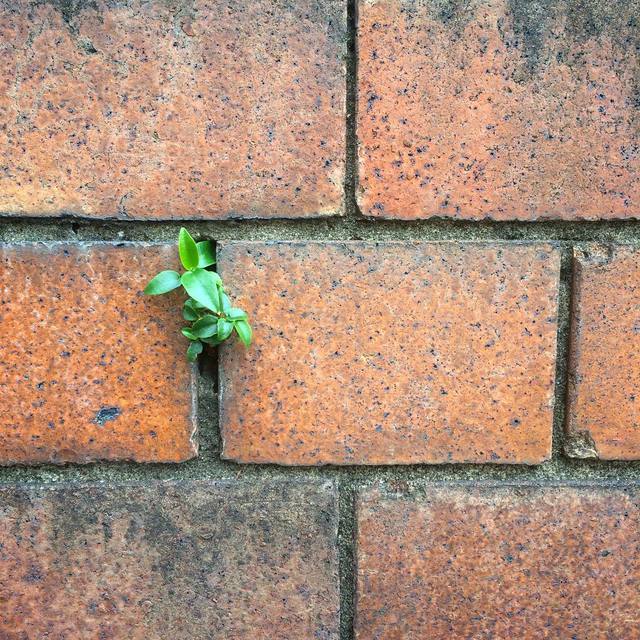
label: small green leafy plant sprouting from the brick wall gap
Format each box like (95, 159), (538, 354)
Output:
(144, 227), (252, 362)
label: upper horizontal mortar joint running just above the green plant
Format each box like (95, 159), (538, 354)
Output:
(5, 218), (640, 244)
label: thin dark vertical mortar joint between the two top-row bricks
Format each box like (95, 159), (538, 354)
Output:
(344, 0), (359, 218)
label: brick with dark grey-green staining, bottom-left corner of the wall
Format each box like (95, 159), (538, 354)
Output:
(0, 481), (338, 640)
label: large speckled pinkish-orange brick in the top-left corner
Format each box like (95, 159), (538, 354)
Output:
(0, 0), (346, 219)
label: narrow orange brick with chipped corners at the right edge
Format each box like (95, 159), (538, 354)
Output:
(565, 245), (640, 460)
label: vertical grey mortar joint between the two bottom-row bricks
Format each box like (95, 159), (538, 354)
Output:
(338, 476), (356, 640)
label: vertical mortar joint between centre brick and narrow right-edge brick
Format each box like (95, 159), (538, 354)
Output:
(552, 242), (573, 461)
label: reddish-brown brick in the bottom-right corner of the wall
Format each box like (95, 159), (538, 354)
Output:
(355, 487), (640, 640)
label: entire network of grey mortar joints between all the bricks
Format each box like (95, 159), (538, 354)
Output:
(0, 0), (640, 640)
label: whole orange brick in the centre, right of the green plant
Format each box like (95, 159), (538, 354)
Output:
(219, 242), (559, 465)
